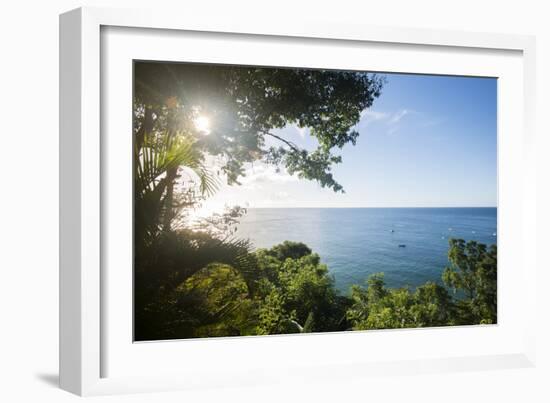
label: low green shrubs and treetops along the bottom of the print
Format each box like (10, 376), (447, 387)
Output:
(136, 239), (497, 340)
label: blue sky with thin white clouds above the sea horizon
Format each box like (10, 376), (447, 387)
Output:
(199, 74), (497, 210)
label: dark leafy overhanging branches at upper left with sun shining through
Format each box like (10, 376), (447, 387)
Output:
(134, 62), (383, 191)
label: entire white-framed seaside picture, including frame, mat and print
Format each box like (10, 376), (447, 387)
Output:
(60, 9), (536, 394)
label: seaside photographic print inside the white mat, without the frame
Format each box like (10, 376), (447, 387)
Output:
(133, 61), (497, 341)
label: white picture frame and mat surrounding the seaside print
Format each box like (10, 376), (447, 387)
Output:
(60, 8), (537, 395)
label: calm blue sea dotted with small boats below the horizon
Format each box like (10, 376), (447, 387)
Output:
(237, 208), (497, 294)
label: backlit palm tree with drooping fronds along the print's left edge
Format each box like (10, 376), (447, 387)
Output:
(134, 131), (264, 340)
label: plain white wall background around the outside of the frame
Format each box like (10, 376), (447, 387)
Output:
(0, 0), (550, 403)
